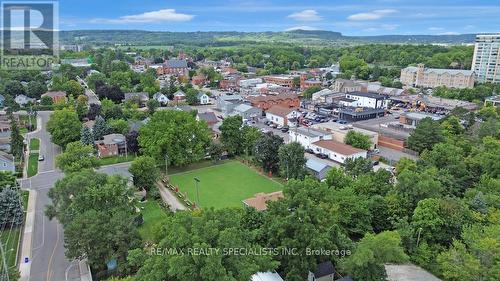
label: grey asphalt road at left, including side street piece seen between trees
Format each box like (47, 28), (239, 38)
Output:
(21, 112), (128, 281)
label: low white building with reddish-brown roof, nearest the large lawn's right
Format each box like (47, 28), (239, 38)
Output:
(311, 140), (367, 164)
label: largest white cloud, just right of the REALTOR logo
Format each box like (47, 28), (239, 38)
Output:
(91, 9), (194, 24)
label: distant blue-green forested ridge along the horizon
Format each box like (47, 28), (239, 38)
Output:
(59, 30), (475, 46)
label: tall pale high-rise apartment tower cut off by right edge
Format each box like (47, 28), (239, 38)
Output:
(472, 34), (500, 83)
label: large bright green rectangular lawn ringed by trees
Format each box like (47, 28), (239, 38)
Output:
(170, 161), (283, 208)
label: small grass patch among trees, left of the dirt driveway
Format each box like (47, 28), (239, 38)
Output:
(139, 199), (167, 241)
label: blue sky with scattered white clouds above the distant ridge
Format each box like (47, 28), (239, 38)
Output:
(54, 0), (500, 35)
